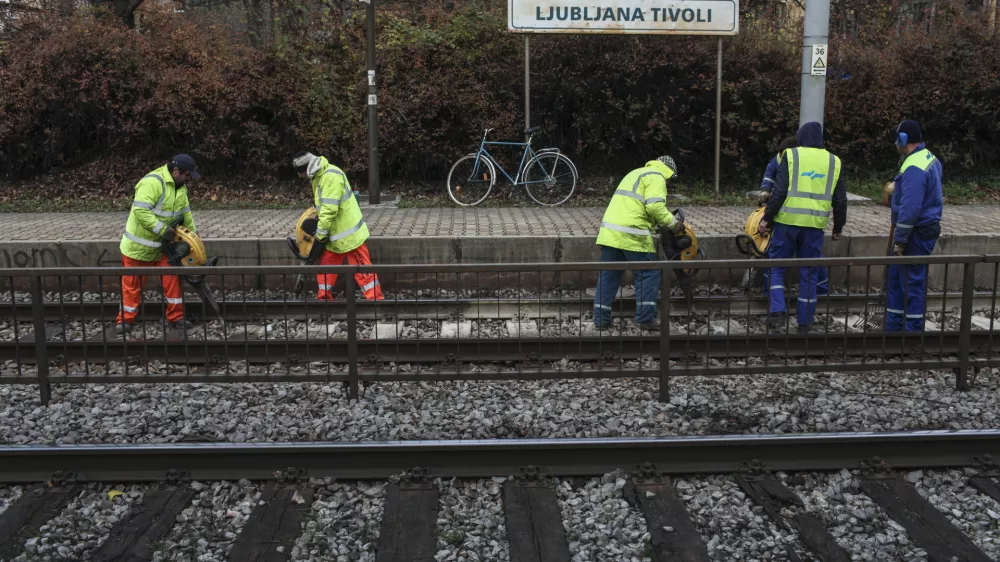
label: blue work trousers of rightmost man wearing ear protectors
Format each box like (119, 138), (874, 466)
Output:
(885, 223), (941, 332)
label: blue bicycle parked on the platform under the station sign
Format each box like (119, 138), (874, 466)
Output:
(448, 127), (578, 207)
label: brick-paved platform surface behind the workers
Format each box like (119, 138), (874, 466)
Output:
(0, 204), (1000, 241)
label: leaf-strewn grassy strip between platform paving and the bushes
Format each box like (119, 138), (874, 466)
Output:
(0, 176), (1000, 213)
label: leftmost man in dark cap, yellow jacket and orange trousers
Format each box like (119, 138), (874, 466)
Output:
(115, 154), (201, 334)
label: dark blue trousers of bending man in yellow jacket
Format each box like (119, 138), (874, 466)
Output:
(594, 246), (660, 328)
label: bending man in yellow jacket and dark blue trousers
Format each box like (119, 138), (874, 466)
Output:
(594, 156), (684, 331)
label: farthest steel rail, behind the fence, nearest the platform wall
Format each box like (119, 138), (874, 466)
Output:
(0, 292), (993, 322)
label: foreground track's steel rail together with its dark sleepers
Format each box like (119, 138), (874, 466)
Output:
(0, 430), (1000, 562)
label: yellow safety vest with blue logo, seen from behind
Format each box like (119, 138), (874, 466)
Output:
(774, 147), (841, 230)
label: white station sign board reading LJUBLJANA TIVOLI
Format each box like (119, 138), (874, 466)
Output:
(507, 0), (740, 35)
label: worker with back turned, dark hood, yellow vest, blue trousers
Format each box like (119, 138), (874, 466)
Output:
(760, 121), (847, 333)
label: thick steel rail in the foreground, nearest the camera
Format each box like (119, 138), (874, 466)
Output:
(0, 430), (1000, 483)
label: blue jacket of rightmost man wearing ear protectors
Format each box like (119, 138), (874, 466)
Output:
(892, 143), (944, 244)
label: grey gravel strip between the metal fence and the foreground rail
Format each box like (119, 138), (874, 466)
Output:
(0, 371), (1000, 444)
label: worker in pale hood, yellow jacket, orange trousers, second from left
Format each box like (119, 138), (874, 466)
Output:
(292, 152), (382, 301)
